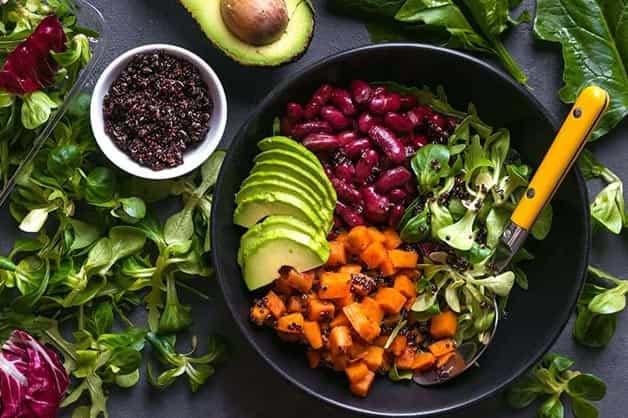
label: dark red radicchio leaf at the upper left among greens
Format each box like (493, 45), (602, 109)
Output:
(0, 16), (66, 94)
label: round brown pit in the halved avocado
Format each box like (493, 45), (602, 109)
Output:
(220, 0), (289, 46)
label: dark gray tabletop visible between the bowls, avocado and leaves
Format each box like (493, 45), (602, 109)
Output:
(0, 0), (628, 418)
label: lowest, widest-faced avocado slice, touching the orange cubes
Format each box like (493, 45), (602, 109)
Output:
(243, 227), (329, 290)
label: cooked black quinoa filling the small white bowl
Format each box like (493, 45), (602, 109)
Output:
(103, 51), (213, 171)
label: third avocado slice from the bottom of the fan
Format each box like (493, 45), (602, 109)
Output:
(233, 192), (329, 231)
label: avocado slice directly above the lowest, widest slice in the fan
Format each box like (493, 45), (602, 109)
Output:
(238, 215), (329, 266)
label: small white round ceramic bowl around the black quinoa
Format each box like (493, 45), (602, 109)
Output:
(90, 44), (227, 180)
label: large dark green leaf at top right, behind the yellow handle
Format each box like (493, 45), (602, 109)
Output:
(534, 0), (628, 140)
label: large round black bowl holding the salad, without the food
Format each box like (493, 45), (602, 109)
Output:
(212, 44), (590, 416)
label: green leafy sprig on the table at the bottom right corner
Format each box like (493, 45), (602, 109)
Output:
(506, 354), (606, 418)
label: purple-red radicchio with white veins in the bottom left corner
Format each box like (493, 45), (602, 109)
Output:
(0, 330), (69, 418)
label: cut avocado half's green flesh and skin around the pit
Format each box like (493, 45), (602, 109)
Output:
(180, 0), (314, 66)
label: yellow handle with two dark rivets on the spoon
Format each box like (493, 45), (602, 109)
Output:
(510, 86), (610, 230)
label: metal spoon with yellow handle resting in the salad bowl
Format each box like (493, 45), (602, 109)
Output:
(413, 86), (610, 386)
